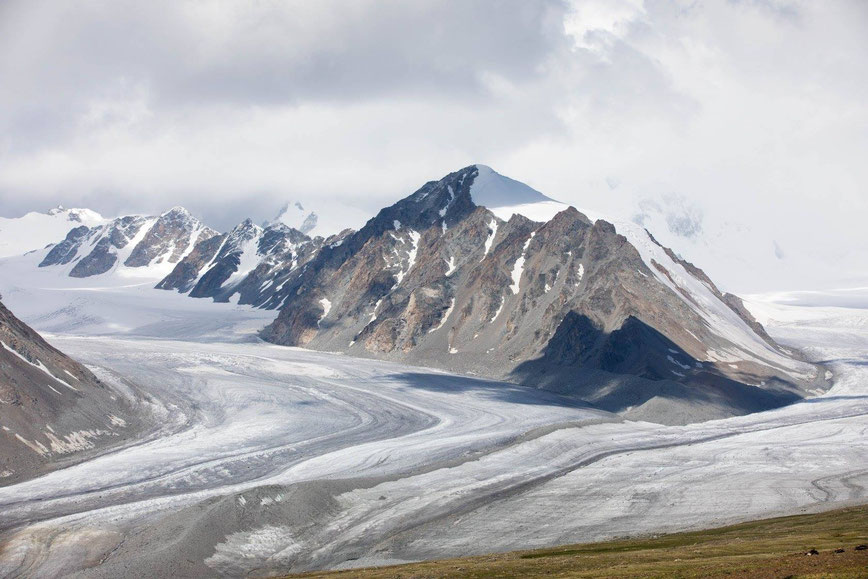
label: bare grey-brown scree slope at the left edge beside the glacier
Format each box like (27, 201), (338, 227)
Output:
(0, 303), (142, 485)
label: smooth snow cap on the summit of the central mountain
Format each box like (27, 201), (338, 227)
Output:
(470, 164), (567, 221)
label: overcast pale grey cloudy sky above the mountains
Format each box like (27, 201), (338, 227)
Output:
(0, 0), (868, 294)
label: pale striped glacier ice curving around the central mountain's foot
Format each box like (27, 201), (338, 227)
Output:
(0, 274), (868, 577)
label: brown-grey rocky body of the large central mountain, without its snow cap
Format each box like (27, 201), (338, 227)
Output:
(254, 167), (822, 422)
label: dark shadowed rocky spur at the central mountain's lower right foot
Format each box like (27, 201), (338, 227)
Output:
(512, 311), (798, 424)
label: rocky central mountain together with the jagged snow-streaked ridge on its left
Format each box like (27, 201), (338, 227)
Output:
(1, 165), (826, 423)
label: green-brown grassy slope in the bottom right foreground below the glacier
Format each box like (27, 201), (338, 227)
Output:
(290, 506), (868, 579)
